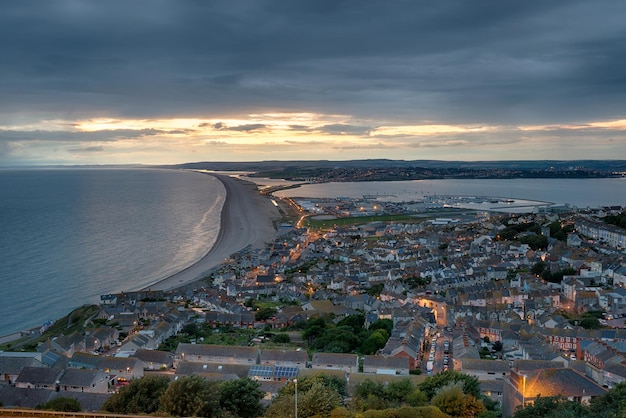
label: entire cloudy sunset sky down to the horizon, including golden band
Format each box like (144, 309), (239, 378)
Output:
(0, 0), (626, 167)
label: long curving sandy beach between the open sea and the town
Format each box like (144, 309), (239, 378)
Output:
(146, 173), (280, 290)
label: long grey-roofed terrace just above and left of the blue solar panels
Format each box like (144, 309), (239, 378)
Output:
(174, 343), (260, 367)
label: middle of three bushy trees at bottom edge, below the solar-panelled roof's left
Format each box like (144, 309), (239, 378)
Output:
(161, 376), (220, 417)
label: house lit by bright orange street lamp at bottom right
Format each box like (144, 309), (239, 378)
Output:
(502, 368), (606, 418)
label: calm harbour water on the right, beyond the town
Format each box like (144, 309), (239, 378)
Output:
(276, 178), (626, 208)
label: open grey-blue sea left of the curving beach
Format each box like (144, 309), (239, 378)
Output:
(0, 169), (225, 335)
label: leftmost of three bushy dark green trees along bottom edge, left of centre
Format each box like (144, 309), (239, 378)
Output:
(102, 376), (170, 414)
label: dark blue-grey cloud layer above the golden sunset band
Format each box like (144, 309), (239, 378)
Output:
(0, 0), (626, 124)
